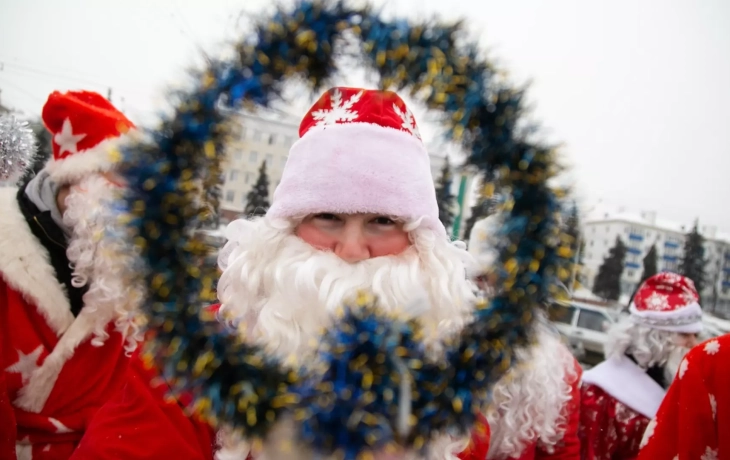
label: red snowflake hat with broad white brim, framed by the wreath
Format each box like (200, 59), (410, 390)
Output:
(267, 87), (446, 236)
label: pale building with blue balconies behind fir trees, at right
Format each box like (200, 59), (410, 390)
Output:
(582, 210), (730, 316)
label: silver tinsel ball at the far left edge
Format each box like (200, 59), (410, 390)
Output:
(0, 115), (36, 181)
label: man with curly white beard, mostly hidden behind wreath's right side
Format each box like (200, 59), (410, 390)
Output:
(460, 214), (582, 460)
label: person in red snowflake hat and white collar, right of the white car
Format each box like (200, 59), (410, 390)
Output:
(579, 272), (702, 460)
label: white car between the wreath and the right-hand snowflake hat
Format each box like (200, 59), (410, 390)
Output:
(548, 301), (618, 364)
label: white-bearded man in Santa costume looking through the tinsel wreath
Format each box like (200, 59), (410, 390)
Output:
(74, 88), (484, 460)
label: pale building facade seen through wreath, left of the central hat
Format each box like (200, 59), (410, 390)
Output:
(221, 112), (299, 223)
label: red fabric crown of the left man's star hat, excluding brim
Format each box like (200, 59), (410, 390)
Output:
(42, 91), (134, 160)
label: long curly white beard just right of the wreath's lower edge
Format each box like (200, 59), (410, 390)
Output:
(486, 320), (579, 460)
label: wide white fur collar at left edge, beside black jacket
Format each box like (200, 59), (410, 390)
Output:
(0, 187), (74, 336)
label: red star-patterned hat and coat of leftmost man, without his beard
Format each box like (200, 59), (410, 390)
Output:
(0, 91), (133, 460)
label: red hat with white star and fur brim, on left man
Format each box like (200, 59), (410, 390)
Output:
(42, 91), (134, 184)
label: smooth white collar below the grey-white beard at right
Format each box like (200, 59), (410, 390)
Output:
(583, 355), (666, 419)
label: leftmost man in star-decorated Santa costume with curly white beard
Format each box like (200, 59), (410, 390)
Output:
(0, 91), (141, 460)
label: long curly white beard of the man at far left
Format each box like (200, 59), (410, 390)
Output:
(63, 174), (144, 352)
